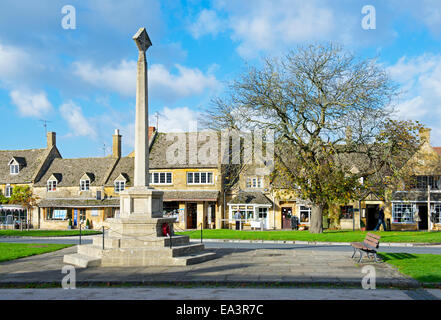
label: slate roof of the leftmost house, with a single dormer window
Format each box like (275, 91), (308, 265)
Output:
(0, 149), (50, 183)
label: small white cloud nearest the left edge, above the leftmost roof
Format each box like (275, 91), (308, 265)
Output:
(9, 90), (52, 117)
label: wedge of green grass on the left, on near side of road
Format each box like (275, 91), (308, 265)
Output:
(0, 243), (73, 262)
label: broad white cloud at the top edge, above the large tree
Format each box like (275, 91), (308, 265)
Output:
(190, 0), (336, 58)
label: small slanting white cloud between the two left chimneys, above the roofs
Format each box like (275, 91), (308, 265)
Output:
(60, 101), (97, 138)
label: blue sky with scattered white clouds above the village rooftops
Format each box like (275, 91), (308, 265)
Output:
(0, 0), (441, 158)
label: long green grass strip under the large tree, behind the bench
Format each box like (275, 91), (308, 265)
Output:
(177, 229), (441, 245)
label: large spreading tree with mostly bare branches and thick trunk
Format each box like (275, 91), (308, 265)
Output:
(202, 44), (420, 233)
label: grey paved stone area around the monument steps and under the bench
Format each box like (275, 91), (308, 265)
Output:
(0, 247), (418, 287)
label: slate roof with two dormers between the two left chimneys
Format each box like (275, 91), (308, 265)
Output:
(35, 157), (118, 187)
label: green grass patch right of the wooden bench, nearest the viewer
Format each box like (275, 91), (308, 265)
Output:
(379, 253), (441, 283)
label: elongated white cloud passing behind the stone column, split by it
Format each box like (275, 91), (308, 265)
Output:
(73, 60), (219, 101)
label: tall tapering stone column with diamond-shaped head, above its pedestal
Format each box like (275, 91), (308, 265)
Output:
(133, 28), (152, 187)
